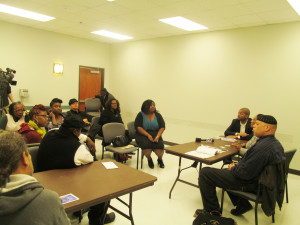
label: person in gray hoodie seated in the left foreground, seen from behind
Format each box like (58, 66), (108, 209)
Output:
(0, 131), (70, 225)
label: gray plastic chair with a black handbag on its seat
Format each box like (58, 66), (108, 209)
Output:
(102, 123), (139, 169)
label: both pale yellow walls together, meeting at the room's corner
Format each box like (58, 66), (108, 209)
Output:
(0, 19), (300, 170)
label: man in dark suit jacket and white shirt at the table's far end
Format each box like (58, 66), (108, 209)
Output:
(224, 108), (253, 140)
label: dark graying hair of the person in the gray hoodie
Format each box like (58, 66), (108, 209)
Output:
(0, 131), (28, 187)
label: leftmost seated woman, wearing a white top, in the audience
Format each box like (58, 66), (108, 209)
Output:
(0, 102), (29, 131)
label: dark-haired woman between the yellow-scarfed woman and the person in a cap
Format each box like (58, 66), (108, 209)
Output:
(48, 98), (64, 130)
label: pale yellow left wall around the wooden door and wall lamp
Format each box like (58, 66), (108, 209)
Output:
(0, 21), (110, 106)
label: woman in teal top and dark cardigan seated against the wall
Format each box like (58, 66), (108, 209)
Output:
(134, 99), (165, 169)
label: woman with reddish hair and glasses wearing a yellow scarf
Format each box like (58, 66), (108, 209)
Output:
(18, 104), (48, 144)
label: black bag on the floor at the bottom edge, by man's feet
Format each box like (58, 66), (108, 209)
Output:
(193, 212), (236, 225)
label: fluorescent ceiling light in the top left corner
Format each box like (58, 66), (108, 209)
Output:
(0, 4), (55, 22)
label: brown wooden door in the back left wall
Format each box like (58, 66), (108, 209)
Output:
(79, 66), (104, 111)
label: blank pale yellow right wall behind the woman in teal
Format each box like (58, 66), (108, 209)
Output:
(110, 22), (300, 170)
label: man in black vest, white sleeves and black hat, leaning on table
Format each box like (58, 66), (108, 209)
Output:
(37, 115), (115, 225)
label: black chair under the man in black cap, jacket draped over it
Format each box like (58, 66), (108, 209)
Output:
(221, 161), (285, 225)
